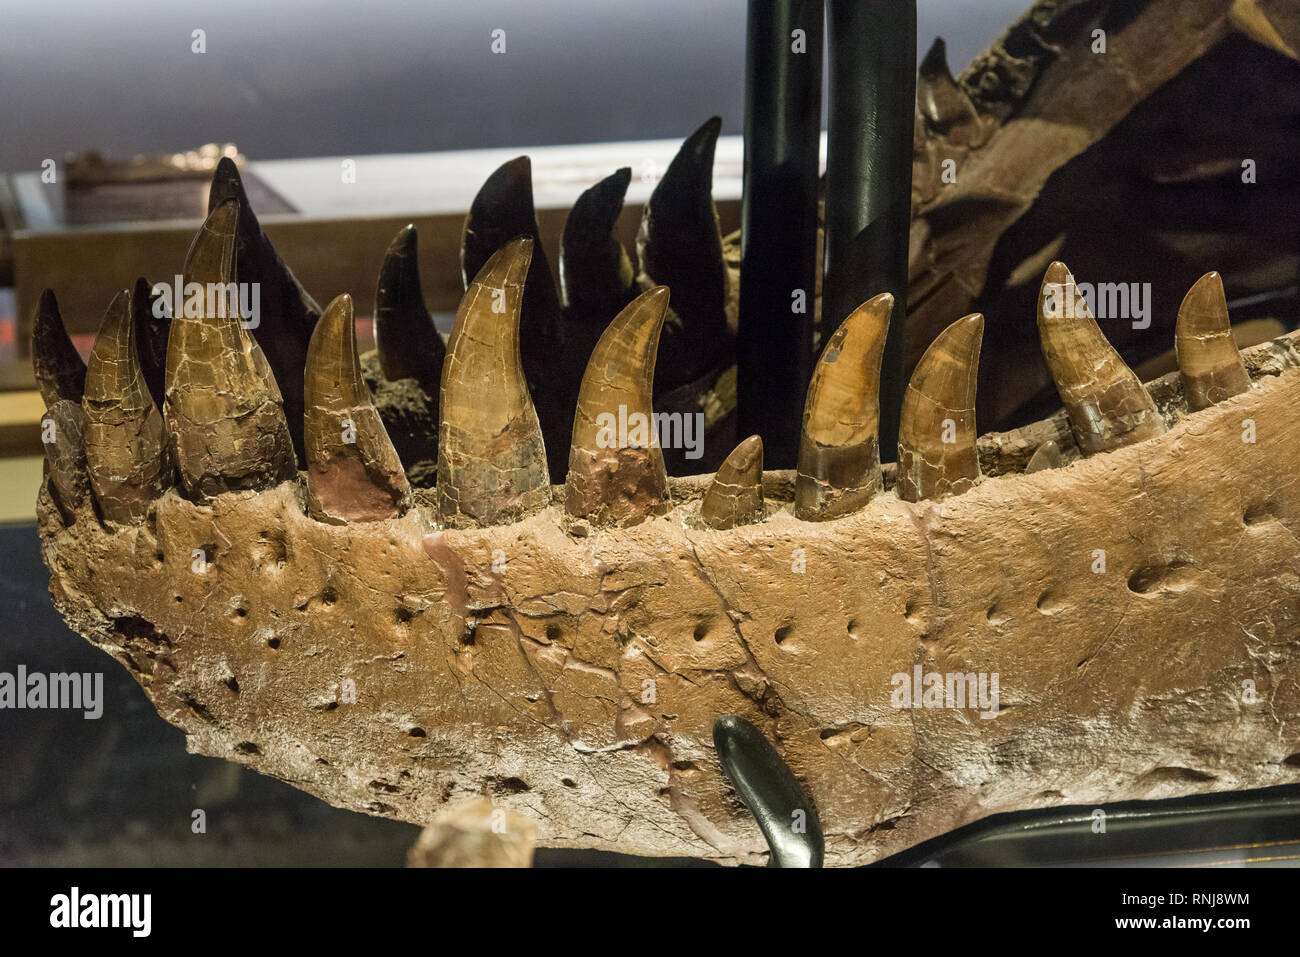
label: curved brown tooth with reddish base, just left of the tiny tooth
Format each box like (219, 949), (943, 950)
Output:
(564, 286), (668, 525)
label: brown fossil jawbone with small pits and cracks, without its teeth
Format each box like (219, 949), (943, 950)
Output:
(38, 334), (1300, 865)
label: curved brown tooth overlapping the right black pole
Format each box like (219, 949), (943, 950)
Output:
(794, 293), (893, 521)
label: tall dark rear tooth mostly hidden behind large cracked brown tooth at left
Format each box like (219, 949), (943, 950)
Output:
(208, 157), (321, 458)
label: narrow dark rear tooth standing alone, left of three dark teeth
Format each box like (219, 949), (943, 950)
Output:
(374, 225), (447, 395)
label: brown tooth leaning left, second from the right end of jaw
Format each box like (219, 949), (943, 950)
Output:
(1039, 263), (1165, 455)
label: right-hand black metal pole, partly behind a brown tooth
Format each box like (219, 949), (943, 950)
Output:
(822, 0), (917, 462)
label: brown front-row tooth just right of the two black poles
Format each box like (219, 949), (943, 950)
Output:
(898, 312), (984, 502)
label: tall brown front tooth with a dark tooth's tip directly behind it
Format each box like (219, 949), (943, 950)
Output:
(438, 237), (550, 525)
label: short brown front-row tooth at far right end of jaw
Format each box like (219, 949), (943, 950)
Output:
(1174, 273), (1251, 412)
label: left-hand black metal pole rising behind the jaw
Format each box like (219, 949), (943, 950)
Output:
(736, 0), (823, 468)
